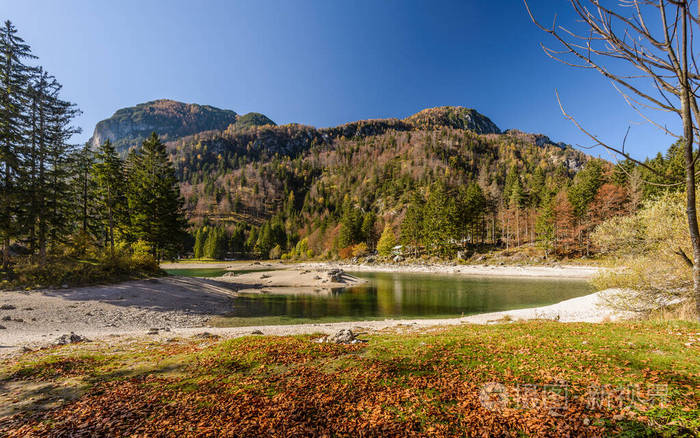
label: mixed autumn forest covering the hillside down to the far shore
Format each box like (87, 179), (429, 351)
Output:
(175, 114), (682, 266)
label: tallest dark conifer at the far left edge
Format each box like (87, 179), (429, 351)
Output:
(0, 21), (36, 270)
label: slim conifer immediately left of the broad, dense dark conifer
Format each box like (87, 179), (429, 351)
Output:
(92, 140), (126, 251)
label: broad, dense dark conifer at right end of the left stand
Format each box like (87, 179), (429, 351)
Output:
(128, 132), (186, 260)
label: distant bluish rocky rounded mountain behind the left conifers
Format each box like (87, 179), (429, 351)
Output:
(90, 99), (275, 153)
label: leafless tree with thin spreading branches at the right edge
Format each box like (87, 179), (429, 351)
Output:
(524, 0), (700, 322)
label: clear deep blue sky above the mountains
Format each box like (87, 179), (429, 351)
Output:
(0, 0), (673, 158)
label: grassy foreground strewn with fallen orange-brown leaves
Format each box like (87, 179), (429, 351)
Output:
(0, 322), (700, 437)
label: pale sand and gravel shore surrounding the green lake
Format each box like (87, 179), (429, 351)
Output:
(0, 263), (625, 357)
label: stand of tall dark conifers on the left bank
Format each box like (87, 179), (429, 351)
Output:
(0, 21), (186, 288)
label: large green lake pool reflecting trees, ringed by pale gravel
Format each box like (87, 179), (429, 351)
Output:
(213, 272), (592, 325)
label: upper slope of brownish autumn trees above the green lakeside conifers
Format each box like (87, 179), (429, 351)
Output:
(169, 107), (590, 230)
